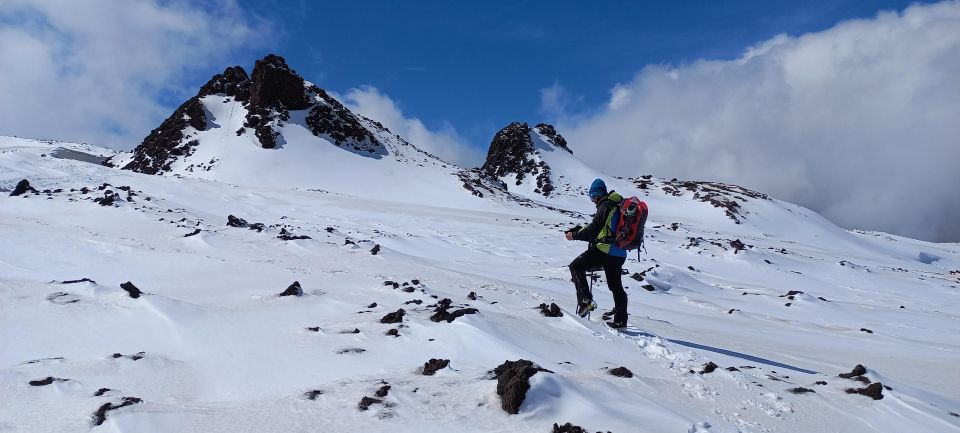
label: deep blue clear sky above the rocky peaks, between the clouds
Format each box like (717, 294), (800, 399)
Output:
(223, 0), (928, 149)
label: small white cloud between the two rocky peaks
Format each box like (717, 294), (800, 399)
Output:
(340, 86), (486, 167)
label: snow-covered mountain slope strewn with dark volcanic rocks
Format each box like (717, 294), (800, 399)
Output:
(0, 134), (960, 433)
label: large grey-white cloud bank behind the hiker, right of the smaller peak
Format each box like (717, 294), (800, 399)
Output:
(556, 1), (960, 242)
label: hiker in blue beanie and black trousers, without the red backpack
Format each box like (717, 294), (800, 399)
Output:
(566, 179), (627, 328)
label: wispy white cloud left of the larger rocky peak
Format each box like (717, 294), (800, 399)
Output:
(0, 0), (263, 149)
